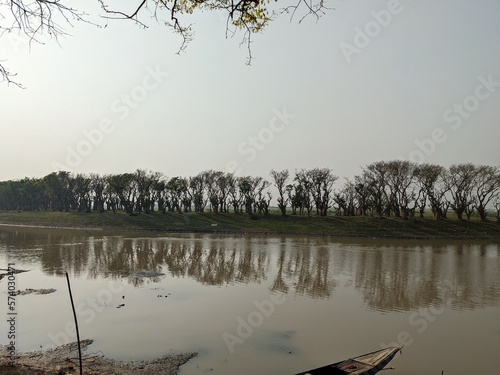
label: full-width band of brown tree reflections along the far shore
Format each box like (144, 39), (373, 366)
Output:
(0, 228), (500, 311)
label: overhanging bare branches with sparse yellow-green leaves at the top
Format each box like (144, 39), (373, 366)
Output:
(0, 0), (327, 86)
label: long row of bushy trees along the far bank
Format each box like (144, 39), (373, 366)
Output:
(0, 160), (500, 220)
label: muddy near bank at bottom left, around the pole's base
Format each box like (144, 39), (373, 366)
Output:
(0, 340), (196, 375)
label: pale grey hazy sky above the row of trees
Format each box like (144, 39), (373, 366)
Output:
(0, 0), (500, 180)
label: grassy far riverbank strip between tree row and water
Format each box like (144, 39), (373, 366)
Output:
(0, 211), (500, 239)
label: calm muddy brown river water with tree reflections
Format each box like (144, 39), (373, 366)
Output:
(0, 227), (500, 375)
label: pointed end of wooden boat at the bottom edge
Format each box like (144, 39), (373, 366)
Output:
(296, 346), (403, 375)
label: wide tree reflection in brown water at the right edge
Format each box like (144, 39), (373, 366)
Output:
(354, 244), (500, 311)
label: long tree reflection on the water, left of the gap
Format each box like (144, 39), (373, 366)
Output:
(35, 236), (334, 298)
